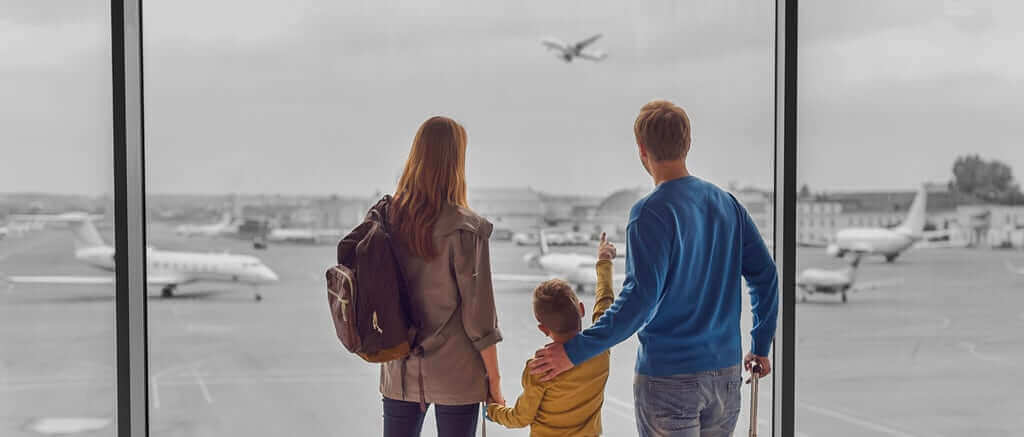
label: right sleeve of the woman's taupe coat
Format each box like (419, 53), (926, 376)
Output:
(452, 220), (502, 350)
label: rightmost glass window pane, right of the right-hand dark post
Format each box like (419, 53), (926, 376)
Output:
(796, 0), (1024, 436)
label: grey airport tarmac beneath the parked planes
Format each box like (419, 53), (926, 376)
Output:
(0, 225), (1024, 437)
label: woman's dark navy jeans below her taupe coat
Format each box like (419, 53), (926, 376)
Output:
(384, 397), (480, 437)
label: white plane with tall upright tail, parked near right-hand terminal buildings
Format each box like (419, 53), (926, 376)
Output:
(826, 185), (928, 262)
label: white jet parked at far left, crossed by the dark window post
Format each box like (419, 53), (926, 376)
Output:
(6, 220), (278, 301)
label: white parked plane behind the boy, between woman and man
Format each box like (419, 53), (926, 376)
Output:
(490, 230), (626, 294)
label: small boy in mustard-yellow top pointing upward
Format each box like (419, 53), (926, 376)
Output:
(487, 232), (615, 437)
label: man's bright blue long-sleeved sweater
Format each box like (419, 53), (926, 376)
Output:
(565, 176), (778, 377)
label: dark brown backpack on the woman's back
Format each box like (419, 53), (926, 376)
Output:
(327, 195), (417, 362)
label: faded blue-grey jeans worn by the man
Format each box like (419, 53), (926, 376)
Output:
(633, 364), (742, 437)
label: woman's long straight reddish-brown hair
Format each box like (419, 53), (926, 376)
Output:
(390, 117), (467, 259)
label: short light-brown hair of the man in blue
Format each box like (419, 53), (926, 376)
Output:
(633, 100), (690, 161)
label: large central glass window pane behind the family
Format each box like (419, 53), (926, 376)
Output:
(143, 0), (775, 437)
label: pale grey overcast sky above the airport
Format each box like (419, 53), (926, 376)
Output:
(0, 0), (1024, 195)
